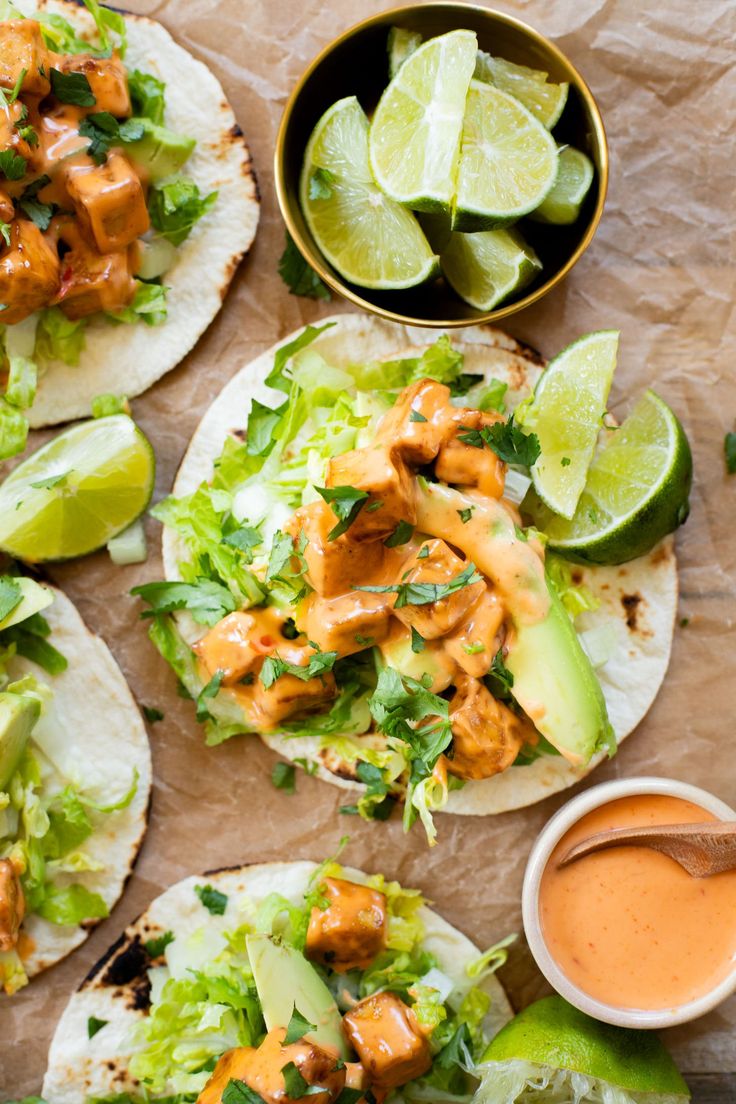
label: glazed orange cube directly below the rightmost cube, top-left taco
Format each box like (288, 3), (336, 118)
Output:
(55, 220), (136, 319)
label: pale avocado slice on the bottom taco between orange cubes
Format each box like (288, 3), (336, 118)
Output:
(245, 934), (349, 1060)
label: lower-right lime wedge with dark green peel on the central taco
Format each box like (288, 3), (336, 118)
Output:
(524, 391), (693, 563)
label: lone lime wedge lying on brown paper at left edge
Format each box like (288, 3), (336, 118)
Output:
(0, 414), (156, 563)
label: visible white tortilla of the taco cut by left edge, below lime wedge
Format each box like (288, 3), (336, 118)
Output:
(2, 587), (151, 977)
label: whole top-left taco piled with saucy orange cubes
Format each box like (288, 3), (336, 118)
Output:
(0, 0), (258, 455)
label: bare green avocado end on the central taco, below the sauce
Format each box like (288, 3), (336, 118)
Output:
(505, 580), (615, 766)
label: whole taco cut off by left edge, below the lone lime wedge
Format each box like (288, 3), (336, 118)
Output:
(0, 575), (151, 994)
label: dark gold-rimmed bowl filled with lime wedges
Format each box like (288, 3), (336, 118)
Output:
(275, 3), (608, 327)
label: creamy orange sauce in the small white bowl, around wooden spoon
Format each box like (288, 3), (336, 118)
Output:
(540, 795), (736, 1010)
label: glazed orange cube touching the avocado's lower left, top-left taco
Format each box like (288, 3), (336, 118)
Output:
(65, 152), (149, 253)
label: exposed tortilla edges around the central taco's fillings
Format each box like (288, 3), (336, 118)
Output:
(163, 315), (678, 816)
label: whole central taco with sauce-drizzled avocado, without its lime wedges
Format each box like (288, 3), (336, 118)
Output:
(136, 315), (678, 838)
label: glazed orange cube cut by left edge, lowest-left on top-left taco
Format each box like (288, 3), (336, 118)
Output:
(0, 219), (60, 326)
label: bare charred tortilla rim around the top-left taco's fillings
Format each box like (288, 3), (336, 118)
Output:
(17, 0), (259, 428)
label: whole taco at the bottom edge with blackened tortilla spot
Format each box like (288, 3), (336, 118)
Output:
(42, 861), (512, 1104)
